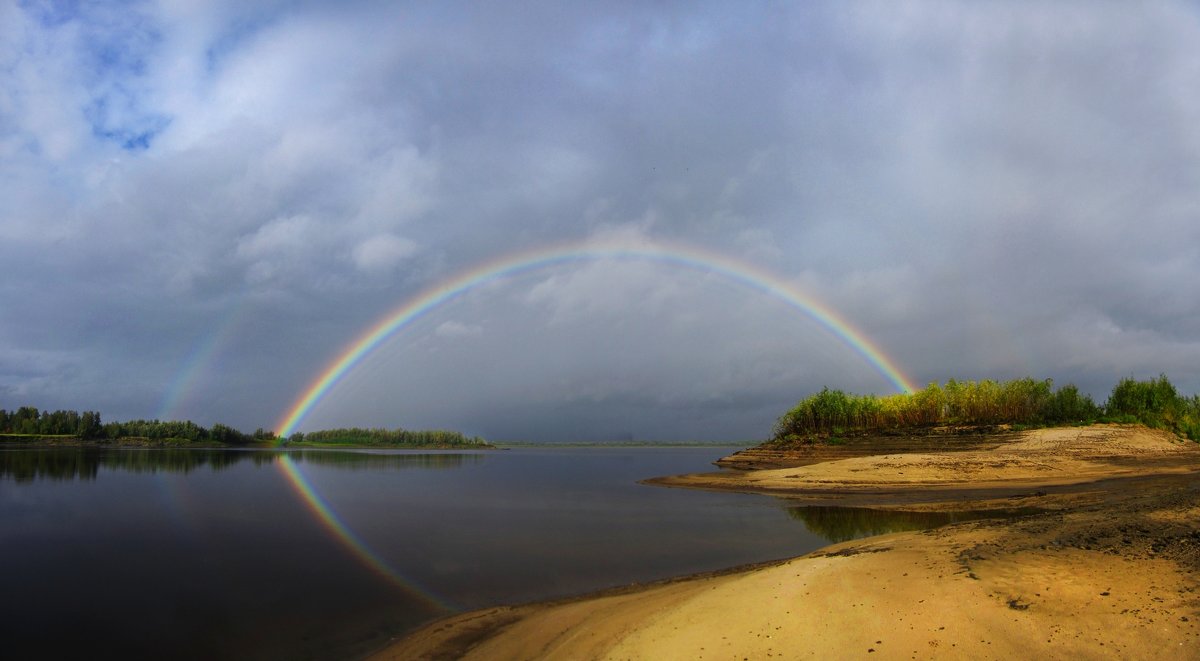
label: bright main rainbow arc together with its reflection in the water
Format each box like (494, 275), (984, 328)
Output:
(276, 236), (916, 609)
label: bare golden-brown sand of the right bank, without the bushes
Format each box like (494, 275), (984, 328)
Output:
(373, 427), (1200, 659)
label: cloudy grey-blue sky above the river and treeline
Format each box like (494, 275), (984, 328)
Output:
(0, 0), (1200, 441)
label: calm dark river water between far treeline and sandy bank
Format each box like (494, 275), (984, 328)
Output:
(0, 447), (902, 659)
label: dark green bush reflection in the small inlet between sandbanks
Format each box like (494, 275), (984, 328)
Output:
(788, 505), (1042, 542)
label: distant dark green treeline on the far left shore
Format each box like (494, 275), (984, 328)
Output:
(0, 407), (492, 449)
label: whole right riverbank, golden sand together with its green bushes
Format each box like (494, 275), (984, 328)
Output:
(374, 377), (1200, 660)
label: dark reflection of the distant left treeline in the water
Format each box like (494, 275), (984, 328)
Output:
(0, 447), (482, 482)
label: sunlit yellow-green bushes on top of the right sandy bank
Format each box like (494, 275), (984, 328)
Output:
(768, 375), (1200, 446)
